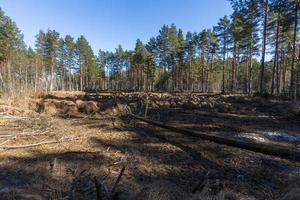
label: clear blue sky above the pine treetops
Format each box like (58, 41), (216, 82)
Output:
(0, 0), (232, 53)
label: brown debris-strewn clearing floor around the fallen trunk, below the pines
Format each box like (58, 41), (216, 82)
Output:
(0, 93), (300, 200)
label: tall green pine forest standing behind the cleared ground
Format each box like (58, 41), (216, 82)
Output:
(0, 0), (300, 100)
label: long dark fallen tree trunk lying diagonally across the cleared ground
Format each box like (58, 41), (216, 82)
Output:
(128, 114), (300, 162)
